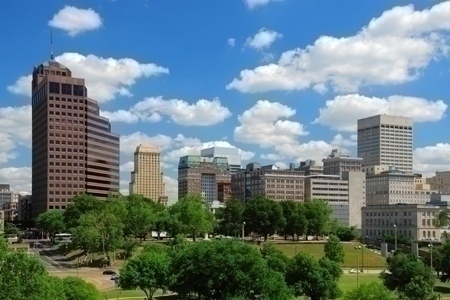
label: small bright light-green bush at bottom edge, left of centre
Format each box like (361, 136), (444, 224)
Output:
(62, 276), (99, 300)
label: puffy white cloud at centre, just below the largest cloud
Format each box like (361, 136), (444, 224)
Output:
(234, 100), (308, 147)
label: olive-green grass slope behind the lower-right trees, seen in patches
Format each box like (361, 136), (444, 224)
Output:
(268, 243), (386, 269)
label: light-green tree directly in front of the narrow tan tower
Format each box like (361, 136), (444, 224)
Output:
(124, 195), (156, 241)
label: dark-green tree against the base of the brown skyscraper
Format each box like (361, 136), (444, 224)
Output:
(64, 194), (105, 229)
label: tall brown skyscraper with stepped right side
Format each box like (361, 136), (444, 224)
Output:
(32, 56), (119, 218)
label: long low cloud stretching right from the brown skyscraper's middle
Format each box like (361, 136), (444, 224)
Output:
(101, 96), (231, 126)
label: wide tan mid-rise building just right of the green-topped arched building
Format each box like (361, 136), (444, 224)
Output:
(231, 162), (305, 203)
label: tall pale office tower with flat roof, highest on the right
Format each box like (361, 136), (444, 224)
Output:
(358, 115), (413, 174)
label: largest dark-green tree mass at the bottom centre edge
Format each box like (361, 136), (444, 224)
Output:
(170, 239), (292, 300)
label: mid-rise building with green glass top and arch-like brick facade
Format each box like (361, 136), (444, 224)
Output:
(178, 155), (230, 204)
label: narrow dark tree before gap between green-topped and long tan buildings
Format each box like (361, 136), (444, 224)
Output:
(216, 199), (244, 236)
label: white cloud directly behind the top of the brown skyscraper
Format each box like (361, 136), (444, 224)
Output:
(8, 53), (169, 102)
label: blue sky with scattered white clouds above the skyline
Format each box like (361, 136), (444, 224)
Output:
(0, 0), (450, 201)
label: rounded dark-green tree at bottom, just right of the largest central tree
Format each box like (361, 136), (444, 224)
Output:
(286, 253), (342, 300)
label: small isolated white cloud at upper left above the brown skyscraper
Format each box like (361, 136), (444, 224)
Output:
(48, 6), (102, 36)
